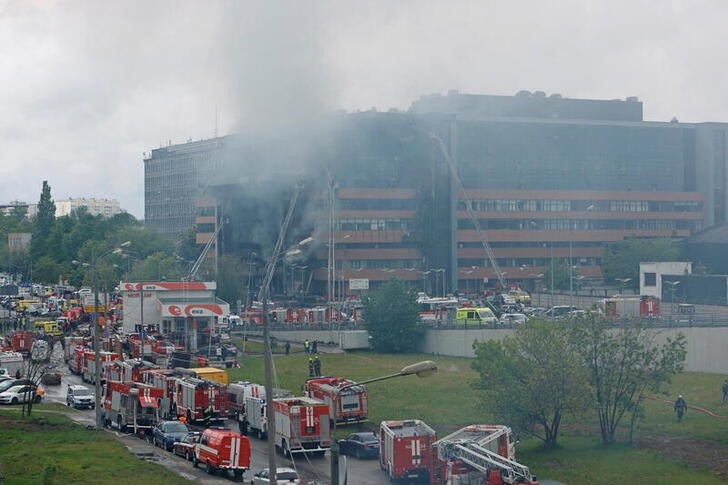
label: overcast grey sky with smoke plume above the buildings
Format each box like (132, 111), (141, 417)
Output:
(0, 0), (728, 217)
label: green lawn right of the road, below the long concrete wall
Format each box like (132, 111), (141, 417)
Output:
(230, 346), (728, 485)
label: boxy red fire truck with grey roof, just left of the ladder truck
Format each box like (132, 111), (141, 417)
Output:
(379, 419), (437, 480)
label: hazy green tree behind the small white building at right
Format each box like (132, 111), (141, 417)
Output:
(603, 236), (680, 285)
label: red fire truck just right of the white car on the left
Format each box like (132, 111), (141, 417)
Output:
(103, 381), (164, 434)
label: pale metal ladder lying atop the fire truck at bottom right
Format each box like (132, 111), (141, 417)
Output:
(440, 441), (531, 483)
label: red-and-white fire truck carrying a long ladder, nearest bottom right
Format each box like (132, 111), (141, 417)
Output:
(429, 424), (538, 485)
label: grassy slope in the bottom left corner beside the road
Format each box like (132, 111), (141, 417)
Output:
(0, 406), (190, 485)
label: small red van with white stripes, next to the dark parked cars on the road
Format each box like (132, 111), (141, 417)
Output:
(192, 428), (250, 481)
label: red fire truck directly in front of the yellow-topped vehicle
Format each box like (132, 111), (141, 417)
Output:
(172, 377), (228, 423)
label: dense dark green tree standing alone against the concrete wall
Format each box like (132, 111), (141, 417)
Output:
(364, 279), (425, 354)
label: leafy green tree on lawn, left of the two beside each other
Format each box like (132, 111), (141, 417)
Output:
(471, 321), (589, 446)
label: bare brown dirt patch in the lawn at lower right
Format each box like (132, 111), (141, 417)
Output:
(635, 436), (728, 482)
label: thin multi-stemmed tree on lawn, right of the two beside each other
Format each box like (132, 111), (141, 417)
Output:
(570, 317), (687, 444)
